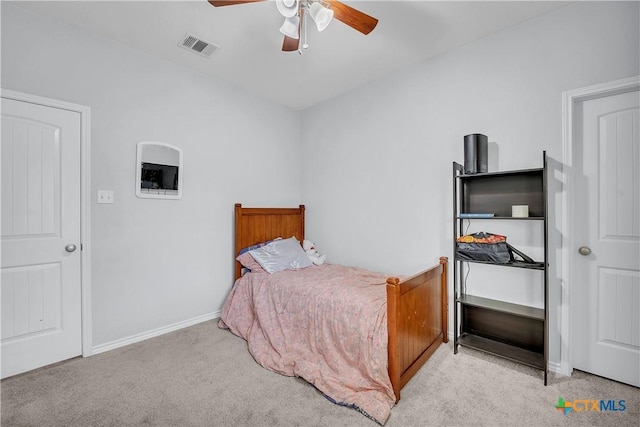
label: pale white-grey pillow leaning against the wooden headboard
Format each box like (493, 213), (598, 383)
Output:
(249, 237), (313, 273)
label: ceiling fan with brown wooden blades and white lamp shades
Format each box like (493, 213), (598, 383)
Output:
(208, 0), (378, 54)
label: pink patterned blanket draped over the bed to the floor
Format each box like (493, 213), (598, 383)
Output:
(219, 264), (395, 424)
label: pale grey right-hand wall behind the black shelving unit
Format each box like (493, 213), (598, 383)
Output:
(302, 2), (640, 362)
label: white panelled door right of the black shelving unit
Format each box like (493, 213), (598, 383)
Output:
(569, 82), (640, 386)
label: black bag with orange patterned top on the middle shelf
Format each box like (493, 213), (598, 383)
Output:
(456, 231), (535, 264)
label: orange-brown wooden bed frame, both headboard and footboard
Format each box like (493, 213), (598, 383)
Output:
(234, 203), (449, 402)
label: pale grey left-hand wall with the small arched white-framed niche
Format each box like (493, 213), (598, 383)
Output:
(1, 2), (301, 347)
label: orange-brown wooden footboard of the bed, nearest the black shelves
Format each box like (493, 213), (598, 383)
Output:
(387, 257), (449, 402)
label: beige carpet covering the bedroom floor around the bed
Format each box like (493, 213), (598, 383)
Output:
(0, 321), (640, 427)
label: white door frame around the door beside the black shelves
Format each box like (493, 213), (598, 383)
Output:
(559, 76), (640, 376)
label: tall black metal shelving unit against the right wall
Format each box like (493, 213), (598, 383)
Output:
(453, 152), (549, 385)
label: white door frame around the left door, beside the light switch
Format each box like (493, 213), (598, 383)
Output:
(0, 89), (93, 357)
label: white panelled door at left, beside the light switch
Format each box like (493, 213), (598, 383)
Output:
(0, 98), (82, 378)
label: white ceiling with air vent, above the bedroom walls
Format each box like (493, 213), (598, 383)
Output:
(11, 0), (568, 109)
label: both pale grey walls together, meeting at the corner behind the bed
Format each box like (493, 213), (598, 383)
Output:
(1, 2), (640, 361)
